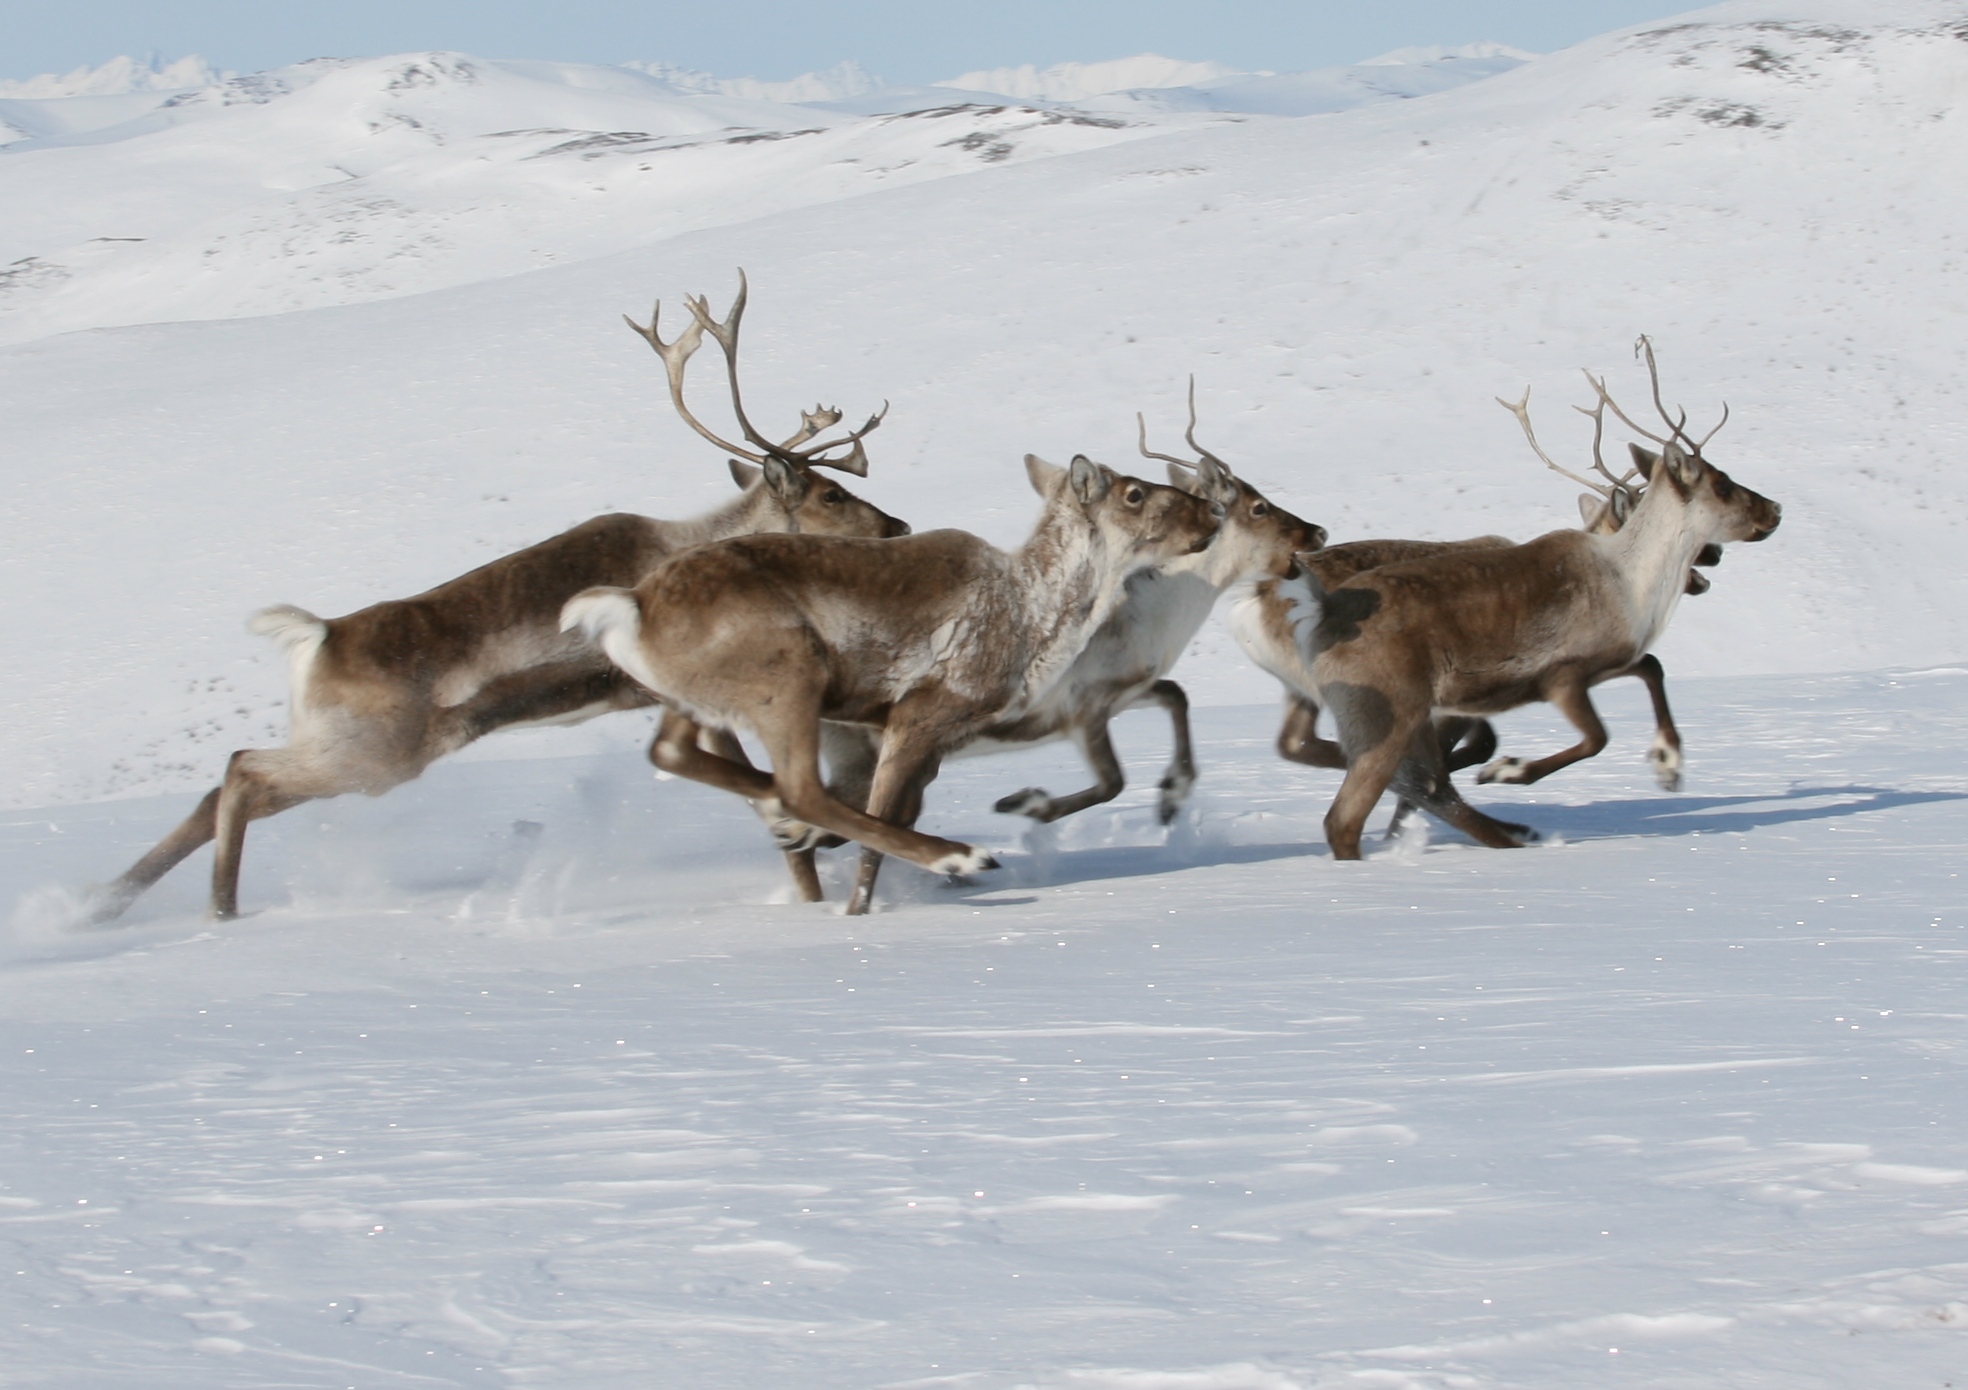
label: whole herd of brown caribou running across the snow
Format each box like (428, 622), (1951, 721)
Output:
(91, 272), (1781, 921)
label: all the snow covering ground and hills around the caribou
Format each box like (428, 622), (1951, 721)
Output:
(0, 0), (1968, 1390)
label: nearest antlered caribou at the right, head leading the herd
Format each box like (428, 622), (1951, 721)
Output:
(1267, 337), (1783, 858)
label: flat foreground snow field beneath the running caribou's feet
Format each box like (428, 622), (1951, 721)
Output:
(0, 667), (1968, 1390)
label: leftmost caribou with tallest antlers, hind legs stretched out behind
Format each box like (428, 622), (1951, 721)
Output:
(89, 272), (909, 923)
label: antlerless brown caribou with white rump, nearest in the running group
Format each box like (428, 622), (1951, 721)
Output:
(563, 444), (1222, 914)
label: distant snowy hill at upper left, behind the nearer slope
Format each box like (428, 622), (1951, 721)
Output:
(0, 53), (1208, 343)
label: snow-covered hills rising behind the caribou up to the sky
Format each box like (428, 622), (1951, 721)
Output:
(0, 0), (1968, 801)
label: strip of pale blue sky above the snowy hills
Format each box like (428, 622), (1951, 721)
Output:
(0, 0), (1689, 83)
